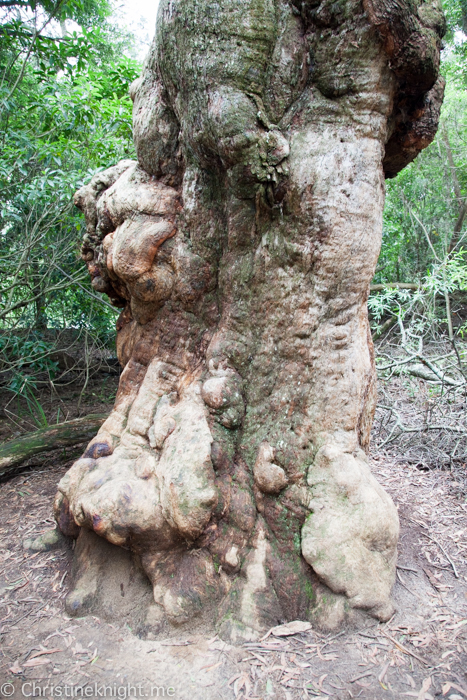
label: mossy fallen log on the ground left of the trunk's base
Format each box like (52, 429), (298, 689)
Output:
(0, 414), (107, 479)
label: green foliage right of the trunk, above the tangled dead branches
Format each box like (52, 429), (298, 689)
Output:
(369, 0), (467, 340)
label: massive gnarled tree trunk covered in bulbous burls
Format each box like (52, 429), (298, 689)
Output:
(56, 0), (443, 636)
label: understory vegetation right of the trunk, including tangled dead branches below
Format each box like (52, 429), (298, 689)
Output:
(368, 2), (467, 477)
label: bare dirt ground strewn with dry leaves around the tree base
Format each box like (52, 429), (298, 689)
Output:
(0, 382), (467, 700)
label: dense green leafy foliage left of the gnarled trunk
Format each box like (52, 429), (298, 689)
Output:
(0, 0), (140, 396)
